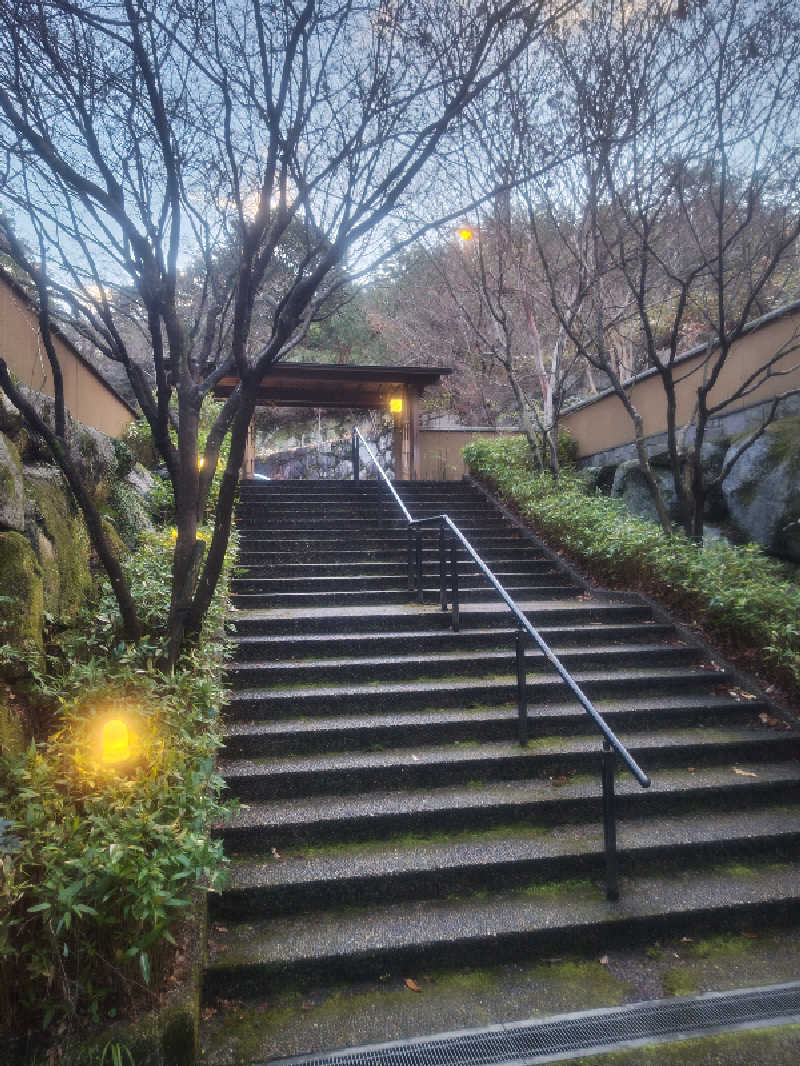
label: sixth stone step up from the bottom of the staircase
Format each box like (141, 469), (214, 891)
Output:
(226, 666), (730, 720)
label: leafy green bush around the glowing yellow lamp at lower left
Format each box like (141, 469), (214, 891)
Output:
(0, 530), (236, 1031)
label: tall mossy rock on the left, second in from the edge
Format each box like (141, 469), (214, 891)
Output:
(25, 468), (91, 623)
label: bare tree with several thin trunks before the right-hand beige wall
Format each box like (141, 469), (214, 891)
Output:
(538, 0), (800, 539)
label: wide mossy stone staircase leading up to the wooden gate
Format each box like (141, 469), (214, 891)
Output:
(204, 482), (800, 1002)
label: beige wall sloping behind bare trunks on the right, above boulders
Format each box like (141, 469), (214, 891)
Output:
(561, 311), (800, 456)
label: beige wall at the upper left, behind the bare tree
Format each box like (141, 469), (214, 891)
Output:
(0, 278), (133, 437)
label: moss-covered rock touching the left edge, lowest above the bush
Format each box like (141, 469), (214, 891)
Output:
(0, 530), (45, 656)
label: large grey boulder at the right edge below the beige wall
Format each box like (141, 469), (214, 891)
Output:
(722, 416), (800, 563)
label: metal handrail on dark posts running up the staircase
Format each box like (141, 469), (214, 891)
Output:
(353, 429), (651, 900)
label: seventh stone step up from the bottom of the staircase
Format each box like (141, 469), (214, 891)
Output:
(227, 641), (702, 687)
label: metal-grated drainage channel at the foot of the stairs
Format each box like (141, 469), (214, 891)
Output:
(265, 981), (800, 1066)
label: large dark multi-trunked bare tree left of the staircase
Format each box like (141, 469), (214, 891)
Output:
(0, 0), (553, 664)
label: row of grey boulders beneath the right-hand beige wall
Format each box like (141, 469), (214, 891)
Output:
(580, 407), (800, 563)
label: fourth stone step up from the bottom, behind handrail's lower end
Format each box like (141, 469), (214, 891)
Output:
(221, 726), (787, 801)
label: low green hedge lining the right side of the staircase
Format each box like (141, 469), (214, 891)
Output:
(464, 438), (800, 687)
